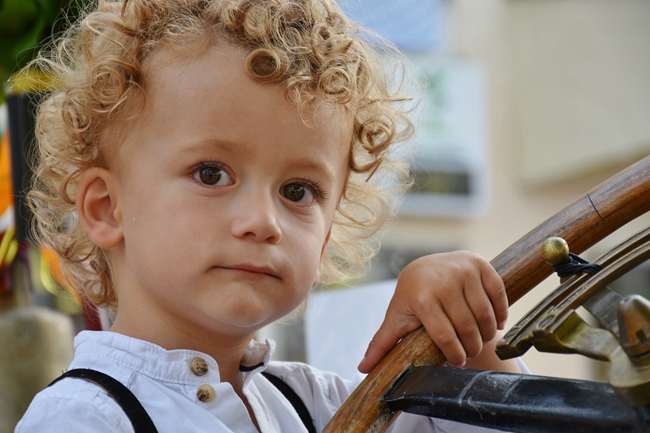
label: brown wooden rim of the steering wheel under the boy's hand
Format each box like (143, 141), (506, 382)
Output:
(323, 156), (650, 433)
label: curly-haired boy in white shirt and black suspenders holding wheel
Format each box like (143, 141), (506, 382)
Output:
(16, 0), (517, 433)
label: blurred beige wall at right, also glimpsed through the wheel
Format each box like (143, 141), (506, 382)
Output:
(384, 0), (650, 378)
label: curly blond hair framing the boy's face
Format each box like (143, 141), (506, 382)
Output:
(29, 0), (413, 307)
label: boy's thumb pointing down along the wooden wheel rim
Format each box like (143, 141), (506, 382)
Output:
(357, 307), (422, 373)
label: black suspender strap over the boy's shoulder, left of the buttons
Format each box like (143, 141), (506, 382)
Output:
(48, 368), (158, 433)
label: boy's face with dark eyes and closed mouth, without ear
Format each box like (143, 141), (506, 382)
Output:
(110, 43), (351, 338)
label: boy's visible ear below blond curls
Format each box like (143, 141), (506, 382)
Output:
(76, 167), (123, 249)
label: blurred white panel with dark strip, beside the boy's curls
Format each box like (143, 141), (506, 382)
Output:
(401, 57), (489, 217)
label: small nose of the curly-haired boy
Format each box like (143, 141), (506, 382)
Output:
(231, 186), (282, 244)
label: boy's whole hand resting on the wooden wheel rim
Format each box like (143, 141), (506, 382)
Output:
(358, 251), (508, 373)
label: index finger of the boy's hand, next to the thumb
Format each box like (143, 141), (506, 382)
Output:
(423, 304), (467, 367)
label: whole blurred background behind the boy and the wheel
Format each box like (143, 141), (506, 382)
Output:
(0, 0), (650, 432)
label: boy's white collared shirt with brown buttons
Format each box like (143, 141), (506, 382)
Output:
(15, 331), (506, 433)
